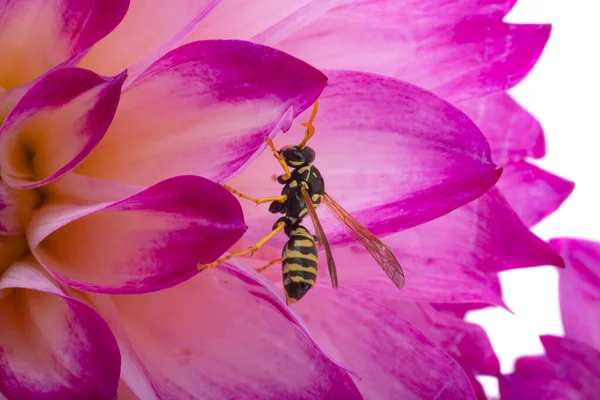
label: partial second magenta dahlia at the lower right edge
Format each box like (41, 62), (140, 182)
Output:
(500, 239), (600, 400)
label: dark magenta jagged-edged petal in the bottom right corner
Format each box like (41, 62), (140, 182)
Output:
(500, 336), (600, 400)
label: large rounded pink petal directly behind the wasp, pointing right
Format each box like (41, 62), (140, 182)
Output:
(230, 71), (500, 243)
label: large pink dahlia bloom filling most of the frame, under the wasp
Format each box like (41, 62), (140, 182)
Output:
(0, 0), (572, 400)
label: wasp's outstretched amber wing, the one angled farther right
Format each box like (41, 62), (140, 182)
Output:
(323, 193), (405, 288)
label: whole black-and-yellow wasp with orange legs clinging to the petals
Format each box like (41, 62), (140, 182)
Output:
(198, 101), (405, 305)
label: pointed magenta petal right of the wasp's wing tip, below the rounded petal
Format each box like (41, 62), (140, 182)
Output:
(398, 188), (564, 272)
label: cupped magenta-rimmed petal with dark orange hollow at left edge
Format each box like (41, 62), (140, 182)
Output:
(0, 68), (126, 189)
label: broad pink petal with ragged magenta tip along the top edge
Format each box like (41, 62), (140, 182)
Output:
(255, 0), (550, 101)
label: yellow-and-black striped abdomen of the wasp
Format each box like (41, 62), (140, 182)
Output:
(281, 226), (318, 304)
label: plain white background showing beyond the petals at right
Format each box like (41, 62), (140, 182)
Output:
(468, 0), (600, 395)
